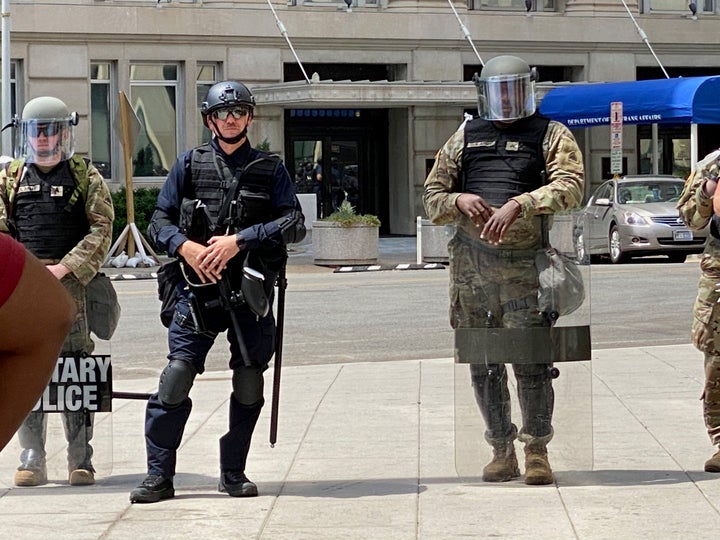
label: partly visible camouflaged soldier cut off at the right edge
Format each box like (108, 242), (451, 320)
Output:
(677, 150), (720, 472)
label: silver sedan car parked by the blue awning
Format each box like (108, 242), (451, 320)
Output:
(574, 175), (708, 263)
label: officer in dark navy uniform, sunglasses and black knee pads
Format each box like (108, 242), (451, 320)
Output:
(130, 81), (305, 503)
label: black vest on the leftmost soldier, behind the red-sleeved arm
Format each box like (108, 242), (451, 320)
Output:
(12, 162), (90, 259)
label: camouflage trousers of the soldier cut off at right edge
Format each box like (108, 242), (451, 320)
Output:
(692, 272), (720, 445)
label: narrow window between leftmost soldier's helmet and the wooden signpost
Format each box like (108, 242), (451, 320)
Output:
(90, 62), (116, 180)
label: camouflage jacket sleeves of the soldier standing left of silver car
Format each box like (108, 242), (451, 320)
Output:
(423, 121), (584, 248)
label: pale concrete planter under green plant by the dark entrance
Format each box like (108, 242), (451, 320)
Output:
(312, 221), (380, 266)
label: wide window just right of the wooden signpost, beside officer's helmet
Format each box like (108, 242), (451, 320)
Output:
(130, 64), (182, 177)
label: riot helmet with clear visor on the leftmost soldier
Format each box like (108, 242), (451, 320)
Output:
(14, 96), (78, 167)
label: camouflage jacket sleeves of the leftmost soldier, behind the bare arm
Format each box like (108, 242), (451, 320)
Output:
(0, 159), (115, 285)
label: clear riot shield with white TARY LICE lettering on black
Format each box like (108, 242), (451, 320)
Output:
(0, 338), (113, 487)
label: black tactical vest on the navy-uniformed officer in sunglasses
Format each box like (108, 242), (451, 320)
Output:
(191, 145), (280, 234)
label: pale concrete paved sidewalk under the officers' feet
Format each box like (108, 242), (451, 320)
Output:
(0, 345), (720, 540)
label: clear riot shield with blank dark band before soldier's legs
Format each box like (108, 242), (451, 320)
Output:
(454, 214), (593, 481)
